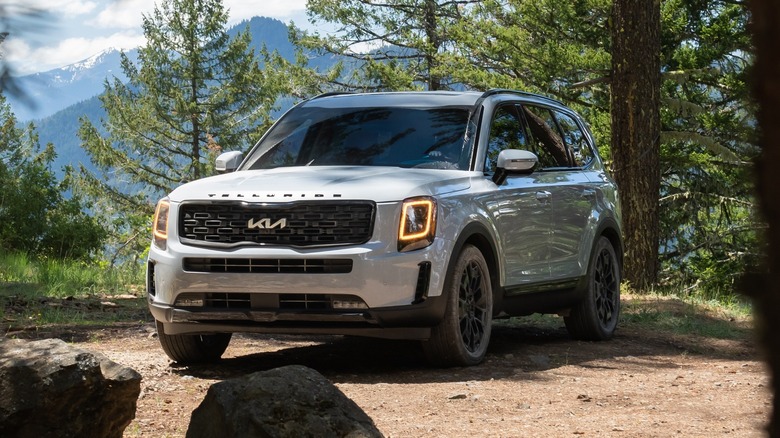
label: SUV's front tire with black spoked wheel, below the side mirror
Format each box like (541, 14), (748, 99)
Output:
(422, 245), (493, 367)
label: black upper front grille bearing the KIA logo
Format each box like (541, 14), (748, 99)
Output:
(179, 201), (376, 246)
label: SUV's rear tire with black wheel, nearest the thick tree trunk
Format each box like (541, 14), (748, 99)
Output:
(563, 236), (620, 341)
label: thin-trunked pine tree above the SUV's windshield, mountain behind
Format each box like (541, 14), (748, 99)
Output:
(295, 0), (478, 90)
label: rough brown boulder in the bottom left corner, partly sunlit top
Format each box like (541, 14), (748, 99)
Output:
(0, 339), (141, 438)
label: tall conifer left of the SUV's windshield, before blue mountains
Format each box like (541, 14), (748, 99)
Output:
(79, 0), (285, 256)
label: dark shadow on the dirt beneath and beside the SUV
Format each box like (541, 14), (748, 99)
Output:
(171, 316), (752, 383)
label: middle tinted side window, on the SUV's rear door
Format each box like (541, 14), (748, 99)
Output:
(523, 104), (574, 168)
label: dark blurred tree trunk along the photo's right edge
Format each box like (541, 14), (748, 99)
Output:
(743, 0), (780, 437)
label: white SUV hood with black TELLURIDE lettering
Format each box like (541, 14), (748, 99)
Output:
(170, 166), (472, 202)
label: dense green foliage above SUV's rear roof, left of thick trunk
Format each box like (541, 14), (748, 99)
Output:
(444, 0), (612, 151)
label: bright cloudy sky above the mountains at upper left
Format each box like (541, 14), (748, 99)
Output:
(0, 0), (308, 76)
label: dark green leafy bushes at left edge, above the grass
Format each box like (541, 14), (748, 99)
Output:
(0, 96), (105, 260)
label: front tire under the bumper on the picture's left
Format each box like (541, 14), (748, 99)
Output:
(156, 321), (233, 364)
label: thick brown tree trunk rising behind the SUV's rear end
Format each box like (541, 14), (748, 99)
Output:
(611, 0), (661, 289)
